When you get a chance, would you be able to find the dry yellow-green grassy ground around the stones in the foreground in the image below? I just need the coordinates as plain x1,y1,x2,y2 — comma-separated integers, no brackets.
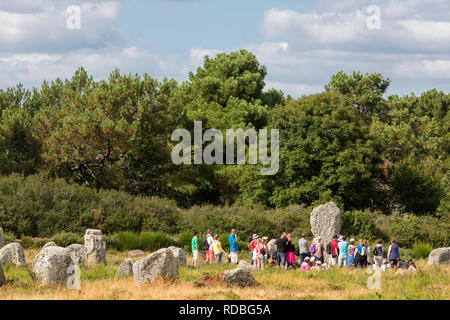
0,249,450,300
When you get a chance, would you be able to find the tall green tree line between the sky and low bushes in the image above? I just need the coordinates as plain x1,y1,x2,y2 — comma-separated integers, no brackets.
0,50,450,217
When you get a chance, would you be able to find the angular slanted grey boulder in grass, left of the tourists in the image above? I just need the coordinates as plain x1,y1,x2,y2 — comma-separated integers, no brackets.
133,249,178,284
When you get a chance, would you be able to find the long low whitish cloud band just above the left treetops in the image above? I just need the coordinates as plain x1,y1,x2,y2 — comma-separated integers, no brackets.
0,47,182,88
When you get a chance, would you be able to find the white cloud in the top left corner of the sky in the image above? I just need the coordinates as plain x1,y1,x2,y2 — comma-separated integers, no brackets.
0,0,125,53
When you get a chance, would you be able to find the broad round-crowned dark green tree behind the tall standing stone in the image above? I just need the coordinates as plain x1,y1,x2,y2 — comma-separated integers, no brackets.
239,92,380,209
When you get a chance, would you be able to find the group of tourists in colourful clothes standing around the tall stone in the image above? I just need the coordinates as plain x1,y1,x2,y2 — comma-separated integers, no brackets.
188,229,416,271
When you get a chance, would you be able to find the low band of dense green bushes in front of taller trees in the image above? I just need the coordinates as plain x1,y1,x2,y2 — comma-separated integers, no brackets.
0,173,450,250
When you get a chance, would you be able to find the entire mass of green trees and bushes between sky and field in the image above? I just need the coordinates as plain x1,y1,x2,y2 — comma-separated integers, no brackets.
0,50,450,234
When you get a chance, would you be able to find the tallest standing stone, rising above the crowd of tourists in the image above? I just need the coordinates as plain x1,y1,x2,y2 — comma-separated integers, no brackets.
310,202,341,263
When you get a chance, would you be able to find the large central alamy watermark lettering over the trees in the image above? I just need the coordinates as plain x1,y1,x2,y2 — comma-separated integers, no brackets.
171,121,280,175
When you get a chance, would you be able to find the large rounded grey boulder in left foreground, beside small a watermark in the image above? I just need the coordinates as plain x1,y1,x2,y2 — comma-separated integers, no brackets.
33,246,73,285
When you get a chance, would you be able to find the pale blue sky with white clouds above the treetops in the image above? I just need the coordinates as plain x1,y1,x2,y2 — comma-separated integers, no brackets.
0,0,450,97
